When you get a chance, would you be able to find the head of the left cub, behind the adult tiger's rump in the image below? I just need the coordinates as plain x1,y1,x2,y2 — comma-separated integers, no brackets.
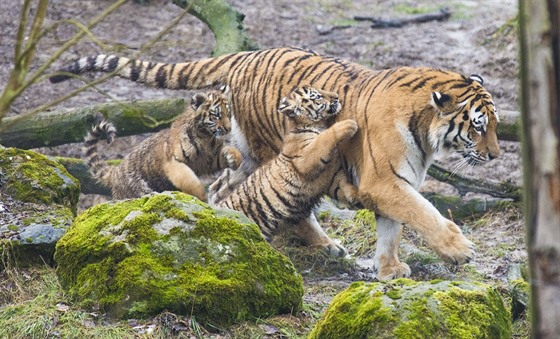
191,86,231,137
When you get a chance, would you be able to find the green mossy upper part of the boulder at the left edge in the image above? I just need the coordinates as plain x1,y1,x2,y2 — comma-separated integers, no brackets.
0,148,80,213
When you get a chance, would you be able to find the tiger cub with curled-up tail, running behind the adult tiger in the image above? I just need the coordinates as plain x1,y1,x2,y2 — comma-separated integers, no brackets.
85,86,242,201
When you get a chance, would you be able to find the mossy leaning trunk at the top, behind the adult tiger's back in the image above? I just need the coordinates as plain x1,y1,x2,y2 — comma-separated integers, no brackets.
173,0,258,56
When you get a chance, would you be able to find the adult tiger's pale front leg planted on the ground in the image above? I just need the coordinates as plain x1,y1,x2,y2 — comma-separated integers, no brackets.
373,216,410,280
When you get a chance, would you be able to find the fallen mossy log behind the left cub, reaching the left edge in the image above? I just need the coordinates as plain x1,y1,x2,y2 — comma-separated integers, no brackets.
0,99,185,149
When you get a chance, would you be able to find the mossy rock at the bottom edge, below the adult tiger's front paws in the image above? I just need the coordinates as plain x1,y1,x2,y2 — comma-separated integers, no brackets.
309,279,511,338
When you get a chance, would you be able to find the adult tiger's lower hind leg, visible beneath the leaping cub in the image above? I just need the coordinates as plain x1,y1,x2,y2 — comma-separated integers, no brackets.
294,213,348,257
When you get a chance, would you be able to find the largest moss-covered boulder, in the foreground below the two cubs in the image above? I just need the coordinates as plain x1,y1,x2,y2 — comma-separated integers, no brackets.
55,192,303,326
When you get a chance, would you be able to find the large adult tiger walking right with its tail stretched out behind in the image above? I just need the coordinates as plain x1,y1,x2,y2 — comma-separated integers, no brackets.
51,48,500,279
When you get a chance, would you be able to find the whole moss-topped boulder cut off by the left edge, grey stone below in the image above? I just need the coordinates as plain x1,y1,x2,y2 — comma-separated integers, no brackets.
0,147,80,267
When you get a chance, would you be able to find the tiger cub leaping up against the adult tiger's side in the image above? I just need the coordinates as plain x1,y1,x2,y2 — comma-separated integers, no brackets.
217,86,358,240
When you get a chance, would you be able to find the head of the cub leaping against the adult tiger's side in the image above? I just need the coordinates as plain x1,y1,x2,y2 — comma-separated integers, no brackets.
278,86,342,127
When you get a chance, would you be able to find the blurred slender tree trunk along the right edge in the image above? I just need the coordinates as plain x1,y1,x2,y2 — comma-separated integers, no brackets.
519,0,560,338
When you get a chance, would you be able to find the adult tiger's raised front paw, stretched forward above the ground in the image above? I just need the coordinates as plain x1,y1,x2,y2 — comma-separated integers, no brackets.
429,221,474,265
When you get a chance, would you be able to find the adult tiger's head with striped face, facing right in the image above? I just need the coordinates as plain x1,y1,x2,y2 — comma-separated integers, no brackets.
430,74,500,165
